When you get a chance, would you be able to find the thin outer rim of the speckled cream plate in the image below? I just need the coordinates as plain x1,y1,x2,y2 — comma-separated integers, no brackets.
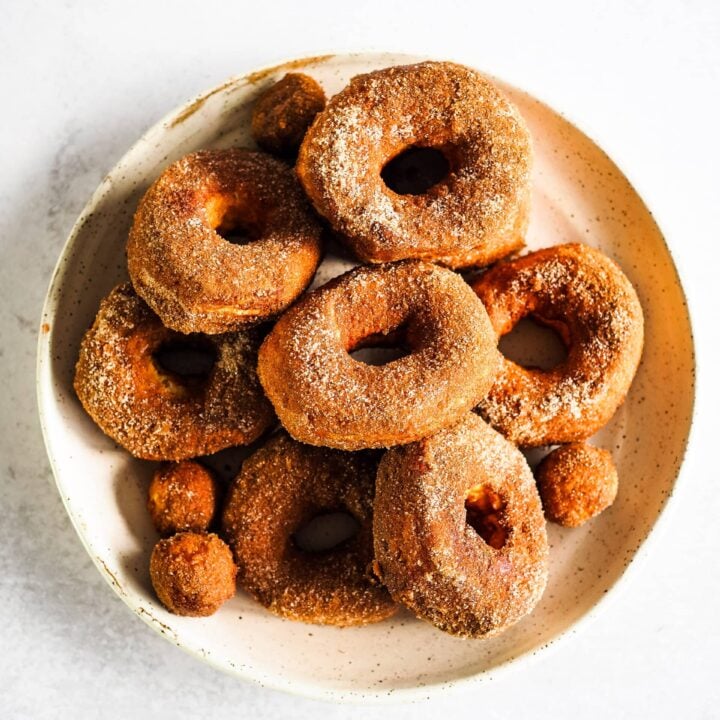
35,49,698,704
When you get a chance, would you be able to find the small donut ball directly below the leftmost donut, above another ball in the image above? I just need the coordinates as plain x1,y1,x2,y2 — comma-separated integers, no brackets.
148,460,219,535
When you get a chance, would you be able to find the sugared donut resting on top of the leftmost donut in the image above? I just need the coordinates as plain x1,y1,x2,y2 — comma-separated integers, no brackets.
127,148,321,334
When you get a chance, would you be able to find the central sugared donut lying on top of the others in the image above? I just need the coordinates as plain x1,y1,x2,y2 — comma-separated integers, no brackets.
258,260,499,450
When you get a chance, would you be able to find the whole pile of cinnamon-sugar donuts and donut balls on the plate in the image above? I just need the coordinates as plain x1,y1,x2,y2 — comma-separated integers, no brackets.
75,62,643,638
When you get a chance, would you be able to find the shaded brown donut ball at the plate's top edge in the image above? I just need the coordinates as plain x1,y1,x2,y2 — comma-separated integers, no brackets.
252,73,325,156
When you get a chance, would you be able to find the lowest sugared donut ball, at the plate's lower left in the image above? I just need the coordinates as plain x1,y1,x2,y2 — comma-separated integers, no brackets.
150,532,237,617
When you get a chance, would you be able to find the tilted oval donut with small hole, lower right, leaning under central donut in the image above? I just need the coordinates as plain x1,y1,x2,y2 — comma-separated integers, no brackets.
373,413,548,638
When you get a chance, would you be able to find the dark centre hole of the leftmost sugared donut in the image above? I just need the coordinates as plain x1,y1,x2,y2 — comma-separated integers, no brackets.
152,333,218,388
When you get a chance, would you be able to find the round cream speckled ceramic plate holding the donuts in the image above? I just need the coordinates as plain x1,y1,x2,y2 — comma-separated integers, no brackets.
38,54,694,700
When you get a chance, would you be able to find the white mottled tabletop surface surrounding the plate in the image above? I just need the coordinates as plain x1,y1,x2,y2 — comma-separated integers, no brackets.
0,0,720,720
